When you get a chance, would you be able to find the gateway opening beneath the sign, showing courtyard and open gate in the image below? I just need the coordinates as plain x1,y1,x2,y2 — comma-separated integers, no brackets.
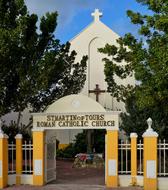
46,130,105,185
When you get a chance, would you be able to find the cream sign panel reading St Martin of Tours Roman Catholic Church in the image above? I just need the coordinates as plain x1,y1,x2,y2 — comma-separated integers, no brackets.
33,112,118,129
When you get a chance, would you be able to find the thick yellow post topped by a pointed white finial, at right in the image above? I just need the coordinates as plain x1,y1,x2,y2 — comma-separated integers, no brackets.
143,118,158,190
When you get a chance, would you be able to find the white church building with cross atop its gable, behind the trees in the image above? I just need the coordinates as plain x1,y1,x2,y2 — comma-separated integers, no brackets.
2,9,135,148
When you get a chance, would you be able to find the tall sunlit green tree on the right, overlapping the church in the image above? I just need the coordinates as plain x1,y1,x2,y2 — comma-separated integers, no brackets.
100,0,168,137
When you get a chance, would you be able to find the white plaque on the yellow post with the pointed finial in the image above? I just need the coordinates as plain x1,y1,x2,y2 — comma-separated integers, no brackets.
146,160,156,179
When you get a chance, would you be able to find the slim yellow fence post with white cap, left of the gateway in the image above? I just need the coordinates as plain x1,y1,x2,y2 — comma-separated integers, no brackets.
15,134,23,185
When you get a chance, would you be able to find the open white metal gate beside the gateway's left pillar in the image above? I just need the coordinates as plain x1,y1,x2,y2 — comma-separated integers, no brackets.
45,132,56,183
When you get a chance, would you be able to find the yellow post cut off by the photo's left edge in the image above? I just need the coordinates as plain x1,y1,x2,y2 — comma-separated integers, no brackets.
0,120,8,189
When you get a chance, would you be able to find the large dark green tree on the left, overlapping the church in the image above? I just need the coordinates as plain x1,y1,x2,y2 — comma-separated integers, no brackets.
0,0,87,127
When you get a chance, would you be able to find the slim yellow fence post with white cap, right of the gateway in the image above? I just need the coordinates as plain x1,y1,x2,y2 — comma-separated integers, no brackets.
130,133,138,185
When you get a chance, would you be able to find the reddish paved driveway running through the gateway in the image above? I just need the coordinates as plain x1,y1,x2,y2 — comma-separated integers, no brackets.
5,161,142,190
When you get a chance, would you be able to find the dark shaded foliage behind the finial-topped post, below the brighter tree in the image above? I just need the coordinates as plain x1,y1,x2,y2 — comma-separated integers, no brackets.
120,95,168,139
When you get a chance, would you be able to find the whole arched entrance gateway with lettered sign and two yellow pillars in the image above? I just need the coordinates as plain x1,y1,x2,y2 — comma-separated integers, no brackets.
32,95,119,187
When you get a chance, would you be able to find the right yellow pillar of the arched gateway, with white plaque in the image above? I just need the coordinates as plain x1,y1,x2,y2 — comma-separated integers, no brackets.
106,129,118,187
